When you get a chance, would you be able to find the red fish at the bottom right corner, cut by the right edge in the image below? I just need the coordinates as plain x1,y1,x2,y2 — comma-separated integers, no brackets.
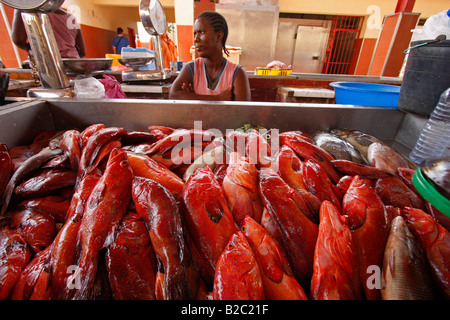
402,207,450,299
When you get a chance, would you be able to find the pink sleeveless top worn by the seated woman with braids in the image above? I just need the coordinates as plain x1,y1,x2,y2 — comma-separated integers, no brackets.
194,57,236,95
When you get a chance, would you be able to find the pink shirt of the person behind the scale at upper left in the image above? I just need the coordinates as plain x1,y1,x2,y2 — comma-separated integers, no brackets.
47,12,80,59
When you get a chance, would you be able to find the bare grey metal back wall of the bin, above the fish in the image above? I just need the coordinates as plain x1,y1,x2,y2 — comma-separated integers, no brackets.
0,99,423,157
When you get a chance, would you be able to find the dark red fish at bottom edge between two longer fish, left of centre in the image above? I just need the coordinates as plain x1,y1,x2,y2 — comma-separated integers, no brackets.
106,212,156,300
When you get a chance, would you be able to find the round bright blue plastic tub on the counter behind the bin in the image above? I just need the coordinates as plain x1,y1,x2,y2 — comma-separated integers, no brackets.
330,82,400,108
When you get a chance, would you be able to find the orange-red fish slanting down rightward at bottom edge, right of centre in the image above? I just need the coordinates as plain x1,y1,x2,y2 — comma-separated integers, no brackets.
241,216,308,300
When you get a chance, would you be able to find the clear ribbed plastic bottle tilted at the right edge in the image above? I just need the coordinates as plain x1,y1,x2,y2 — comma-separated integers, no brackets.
409,88,450,165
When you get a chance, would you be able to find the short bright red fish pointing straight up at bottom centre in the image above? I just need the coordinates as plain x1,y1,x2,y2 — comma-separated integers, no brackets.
213,231,264,300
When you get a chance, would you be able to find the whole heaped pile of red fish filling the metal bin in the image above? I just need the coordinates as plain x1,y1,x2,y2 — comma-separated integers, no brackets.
0,124,450,300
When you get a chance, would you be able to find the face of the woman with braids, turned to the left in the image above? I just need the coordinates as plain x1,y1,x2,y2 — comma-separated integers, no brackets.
194,18,223,58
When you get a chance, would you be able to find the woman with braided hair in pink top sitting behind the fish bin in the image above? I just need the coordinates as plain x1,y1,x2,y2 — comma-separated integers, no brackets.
169,11,251,101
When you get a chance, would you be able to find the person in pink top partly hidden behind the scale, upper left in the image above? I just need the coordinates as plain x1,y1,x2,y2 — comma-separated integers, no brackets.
11,8,86,59
